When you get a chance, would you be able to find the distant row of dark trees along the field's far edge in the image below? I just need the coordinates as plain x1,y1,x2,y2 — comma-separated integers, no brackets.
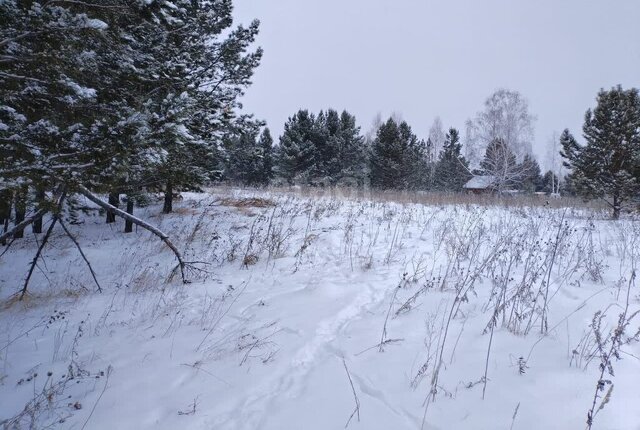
223,109,559,193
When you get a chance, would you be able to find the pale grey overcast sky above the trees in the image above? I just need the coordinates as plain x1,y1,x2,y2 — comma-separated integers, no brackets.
234,0,640,162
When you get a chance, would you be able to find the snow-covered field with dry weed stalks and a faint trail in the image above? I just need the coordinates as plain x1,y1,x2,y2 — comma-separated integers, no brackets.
0,189,640,430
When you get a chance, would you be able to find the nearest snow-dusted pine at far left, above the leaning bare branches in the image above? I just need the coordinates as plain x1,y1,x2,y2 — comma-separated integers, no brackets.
0,0,146,228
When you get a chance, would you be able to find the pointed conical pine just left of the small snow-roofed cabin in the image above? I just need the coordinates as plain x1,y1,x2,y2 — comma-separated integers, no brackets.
434,128,471,191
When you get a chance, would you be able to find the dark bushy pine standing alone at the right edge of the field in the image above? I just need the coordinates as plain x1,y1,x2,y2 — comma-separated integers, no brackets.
561,86,640,219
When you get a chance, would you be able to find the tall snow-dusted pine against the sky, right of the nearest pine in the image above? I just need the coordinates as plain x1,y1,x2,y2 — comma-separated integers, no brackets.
131,0,262,213
